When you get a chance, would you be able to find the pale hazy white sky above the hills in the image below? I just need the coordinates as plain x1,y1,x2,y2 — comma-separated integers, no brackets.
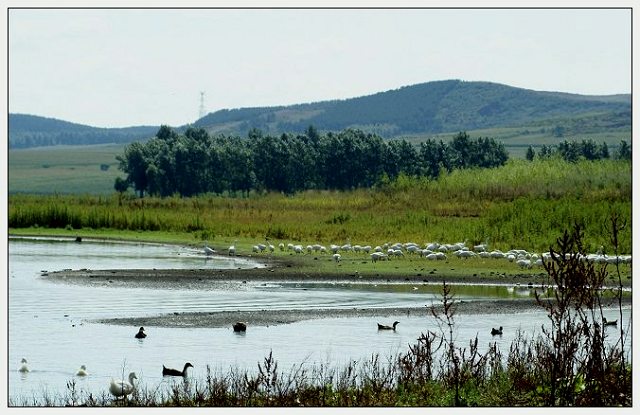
8,4,632,127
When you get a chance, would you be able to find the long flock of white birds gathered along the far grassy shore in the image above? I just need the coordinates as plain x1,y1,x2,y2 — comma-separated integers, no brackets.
224,241,631,269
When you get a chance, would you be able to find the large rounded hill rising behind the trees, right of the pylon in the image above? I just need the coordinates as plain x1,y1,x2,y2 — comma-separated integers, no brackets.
195,80,631,137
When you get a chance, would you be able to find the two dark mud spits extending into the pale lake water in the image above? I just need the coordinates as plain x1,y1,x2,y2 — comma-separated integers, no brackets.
42,259,631,328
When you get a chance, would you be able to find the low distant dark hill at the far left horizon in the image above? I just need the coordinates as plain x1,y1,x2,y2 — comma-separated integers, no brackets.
9,114,159,148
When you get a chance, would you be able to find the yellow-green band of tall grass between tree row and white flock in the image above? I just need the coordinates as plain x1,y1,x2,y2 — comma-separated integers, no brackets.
8,159,631,253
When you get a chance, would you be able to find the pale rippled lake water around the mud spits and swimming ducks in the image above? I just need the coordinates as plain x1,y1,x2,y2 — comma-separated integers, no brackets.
8,238,631,405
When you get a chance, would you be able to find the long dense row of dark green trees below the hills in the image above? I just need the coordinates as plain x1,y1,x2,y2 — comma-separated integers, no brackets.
114,126,508,197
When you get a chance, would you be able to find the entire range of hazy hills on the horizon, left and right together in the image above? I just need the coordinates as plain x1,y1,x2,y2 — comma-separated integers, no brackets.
9,80,631,148
